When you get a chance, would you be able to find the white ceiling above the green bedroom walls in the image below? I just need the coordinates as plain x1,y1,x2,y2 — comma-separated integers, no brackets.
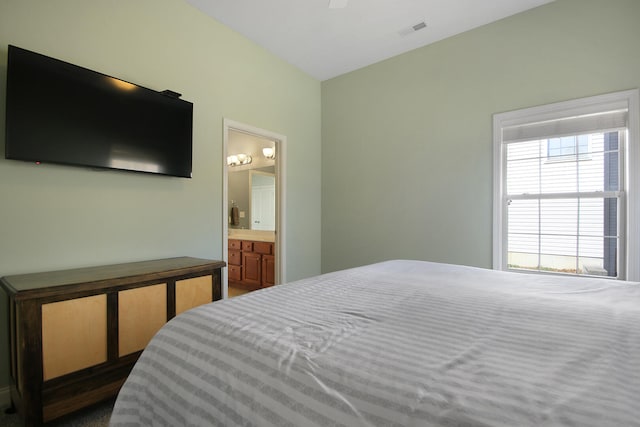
187,0,553,80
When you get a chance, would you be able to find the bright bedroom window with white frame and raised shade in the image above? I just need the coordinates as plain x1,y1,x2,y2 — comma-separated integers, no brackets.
493,90,640,280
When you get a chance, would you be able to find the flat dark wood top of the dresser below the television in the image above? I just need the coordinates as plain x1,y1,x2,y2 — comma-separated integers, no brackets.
1,257,226,294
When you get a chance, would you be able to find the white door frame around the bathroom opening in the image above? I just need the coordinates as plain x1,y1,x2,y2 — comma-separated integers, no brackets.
222,118,287,298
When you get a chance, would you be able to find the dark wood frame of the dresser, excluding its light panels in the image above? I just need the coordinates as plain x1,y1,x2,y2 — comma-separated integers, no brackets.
0,257,225,426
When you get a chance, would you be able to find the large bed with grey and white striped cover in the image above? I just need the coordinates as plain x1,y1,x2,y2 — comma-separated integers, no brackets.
111,260,640,427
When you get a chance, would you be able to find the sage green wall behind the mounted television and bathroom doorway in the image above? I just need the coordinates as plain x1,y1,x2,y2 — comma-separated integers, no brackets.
0,0,321,391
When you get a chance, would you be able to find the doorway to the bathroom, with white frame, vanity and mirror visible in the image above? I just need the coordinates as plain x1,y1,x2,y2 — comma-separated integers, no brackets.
222,119,286,298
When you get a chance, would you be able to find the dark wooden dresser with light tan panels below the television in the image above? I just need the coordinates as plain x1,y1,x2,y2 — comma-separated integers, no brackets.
0,257,225,426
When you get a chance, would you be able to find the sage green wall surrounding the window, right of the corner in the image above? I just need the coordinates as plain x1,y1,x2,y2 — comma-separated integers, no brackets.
322,0,640,272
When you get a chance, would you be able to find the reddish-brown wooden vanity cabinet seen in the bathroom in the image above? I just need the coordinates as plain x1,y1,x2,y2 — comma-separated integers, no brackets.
228,239,276,290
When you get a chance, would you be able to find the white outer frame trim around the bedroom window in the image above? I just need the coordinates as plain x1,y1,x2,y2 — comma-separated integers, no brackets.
493,89,640,281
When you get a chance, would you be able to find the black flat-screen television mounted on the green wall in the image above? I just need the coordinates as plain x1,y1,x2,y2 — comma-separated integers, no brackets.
5,46,193,178
